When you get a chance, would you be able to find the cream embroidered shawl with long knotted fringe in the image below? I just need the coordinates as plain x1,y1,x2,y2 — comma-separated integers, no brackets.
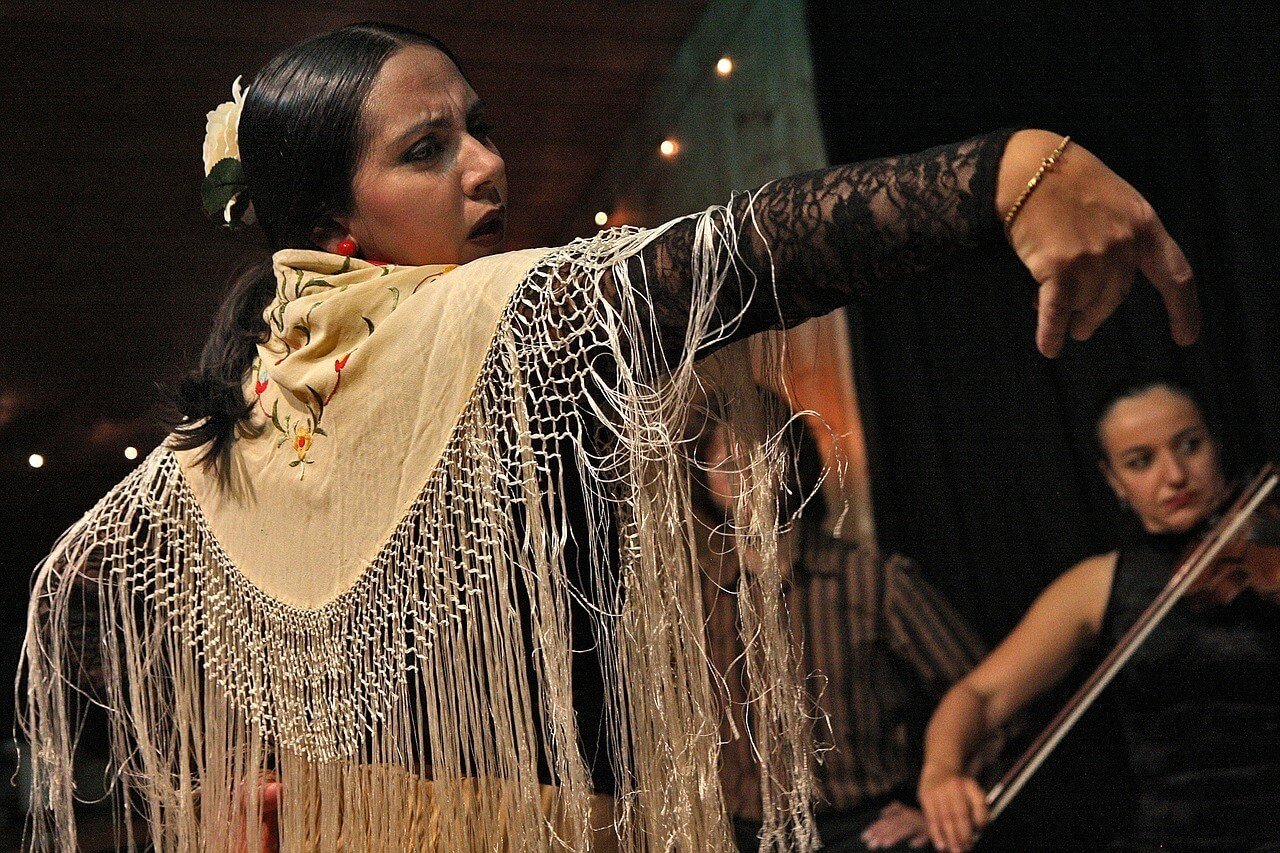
23,209,814,850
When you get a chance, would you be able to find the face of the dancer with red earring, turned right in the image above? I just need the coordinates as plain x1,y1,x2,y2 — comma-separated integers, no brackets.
326,45,507,264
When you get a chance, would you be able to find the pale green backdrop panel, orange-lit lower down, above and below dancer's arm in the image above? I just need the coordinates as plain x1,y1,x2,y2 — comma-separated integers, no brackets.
568,0,876,548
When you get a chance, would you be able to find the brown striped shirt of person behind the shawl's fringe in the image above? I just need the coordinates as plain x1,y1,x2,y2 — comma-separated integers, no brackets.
699,526,986,820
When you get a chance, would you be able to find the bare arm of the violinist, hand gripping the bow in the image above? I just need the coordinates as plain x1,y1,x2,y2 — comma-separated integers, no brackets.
919,552,1116,850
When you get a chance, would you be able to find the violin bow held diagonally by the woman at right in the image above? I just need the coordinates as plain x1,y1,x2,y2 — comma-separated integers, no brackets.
987,462,1280,820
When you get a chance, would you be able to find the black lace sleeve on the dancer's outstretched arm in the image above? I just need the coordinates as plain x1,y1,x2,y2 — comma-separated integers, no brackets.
643,129,1014,356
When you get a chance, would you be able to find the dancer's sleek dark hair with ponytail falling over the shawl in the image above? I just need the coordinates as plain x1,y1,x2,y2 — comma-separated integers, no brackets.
168,22,461,471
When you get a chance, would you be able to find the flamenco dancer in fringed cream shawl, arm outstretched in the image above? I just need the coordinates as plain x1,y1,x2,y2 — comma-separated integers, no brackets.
22,23,1198,850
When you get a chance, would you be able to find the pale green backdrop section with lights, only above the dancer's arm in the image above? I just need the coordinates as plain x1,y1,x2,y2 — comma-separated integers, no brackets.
570,0,827,233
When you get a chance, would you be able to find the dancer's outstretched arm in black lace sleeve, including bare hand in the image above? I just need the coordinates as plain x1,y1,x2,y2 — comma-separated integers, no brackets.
634,131,1199,356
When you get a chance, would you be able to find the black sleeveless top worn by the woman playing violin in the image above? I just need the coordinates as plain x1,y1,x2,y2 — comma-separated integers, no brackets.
1101,527,1280,850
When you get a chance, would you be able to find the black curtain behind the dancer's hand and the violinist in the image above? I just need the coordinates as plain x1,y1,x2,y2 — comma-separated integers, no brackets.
809,0,1280,843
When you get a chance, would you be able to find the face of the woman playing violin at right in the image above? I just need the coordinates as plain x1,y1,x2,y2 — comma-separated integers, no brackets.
1098,386,1226,533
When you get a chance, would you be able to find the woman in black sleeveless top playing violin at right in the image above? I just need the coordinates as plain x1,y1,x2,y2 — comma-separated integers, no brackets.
919,380,1280,850
